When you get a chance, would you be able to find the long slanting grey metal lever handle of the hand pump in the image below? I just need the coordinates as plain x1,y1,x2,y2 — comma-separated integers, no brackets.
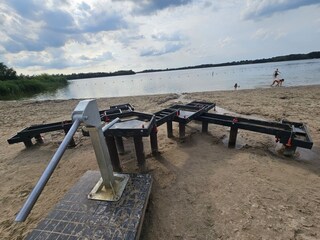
15,119,81,222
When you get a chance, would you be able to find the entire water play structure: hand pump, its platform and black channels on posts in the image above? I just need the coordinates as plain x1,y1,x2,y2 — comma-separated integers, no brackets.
8,100,313,239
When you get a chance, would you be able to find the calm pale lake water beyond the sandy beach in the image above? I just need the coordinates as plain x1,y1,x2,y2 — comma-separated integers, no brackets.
33,59,320,100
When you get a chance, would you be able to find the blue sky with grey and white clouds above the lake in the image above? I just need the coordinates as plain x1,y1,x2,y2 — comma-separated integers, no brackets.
0,0,320,74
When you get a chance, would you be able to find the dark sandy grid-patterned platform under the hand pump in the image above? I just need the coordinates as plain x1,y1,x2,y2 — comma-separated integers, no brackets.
26,171,152,240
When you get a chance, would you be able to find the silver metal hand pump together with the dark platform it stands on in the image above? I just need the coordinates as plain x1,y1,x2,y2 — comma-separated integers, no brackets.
16,100,152,239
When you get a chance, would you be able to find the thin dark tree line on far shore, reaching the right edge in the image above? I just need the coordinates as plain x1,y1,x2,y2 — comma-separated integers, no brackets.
138,52,320,73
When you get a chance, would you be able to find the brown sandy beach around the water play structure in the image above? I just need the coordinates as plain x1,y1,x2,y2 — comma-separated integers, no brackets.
0,86,320,239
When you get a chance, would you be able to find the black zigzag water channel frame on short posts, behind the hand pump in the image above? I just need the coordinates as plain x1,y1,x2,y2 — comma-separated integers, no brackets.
7,101,313,152
